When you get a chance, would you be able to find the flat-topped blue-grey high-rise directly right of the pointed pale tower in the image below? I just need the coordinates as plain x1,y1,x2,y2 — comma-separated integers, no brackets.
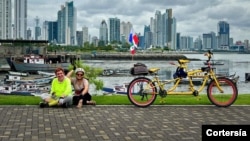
109,18,120,43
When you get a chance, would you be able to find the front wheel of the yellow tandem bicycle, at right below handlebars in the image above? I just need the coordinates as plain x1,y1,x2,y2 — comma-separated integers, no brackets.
207,77,238,107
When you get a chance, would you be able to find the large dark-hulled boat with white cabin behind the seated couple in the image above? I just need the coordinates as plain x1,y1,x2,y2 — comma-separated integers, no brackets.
6,54,77,73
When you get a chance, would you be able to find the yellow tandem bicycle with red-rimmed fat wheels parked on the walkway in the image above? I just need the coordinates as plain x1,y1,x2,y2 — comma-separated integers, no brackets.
127,51,238,107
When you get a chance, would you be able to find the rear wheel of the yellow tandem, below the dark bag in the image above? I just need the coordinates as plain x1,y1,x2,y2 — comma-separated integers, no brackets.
127,77,157,107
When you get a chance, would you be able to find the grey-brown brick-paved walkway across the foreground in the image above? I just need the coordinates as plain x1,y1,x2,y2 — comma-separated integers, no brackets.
0,105,250,141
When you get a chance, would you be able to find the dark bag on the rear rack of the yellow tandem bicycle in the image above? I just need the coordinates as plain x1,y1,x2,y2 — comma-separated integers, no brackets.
130,63,148,75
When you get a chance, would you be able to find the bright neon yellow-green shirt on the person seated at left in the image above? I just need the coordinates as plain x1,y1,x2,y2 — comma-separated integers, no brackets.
50,77,72,97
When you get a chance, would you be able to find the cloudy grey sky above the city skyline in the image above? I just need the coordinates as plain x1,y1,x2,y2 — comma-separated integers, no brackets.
28,0,250,42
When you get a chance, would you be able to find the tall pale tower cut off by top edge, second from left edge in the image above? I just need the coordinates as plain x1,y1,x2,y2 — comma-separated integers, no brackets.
13,0,27,39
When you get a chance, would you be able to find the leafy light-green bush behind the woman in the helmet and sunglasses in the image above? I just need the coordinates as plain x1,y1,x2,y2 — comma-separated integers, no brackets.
69,60,104,90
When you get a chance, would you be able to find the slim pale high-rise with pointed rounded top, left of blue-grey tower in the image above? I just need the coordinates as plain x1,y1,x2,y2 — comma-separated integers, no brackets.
99,20,108,45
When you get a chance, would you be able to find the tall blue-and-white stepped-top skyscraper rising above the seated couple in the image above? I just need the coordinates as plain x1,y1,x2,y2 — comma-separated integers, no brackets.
57,1,77,45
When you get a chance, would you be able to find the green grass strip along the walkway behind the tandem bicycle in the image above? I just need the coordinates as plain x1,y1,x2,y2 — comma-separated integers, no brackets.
0,94,250,105
